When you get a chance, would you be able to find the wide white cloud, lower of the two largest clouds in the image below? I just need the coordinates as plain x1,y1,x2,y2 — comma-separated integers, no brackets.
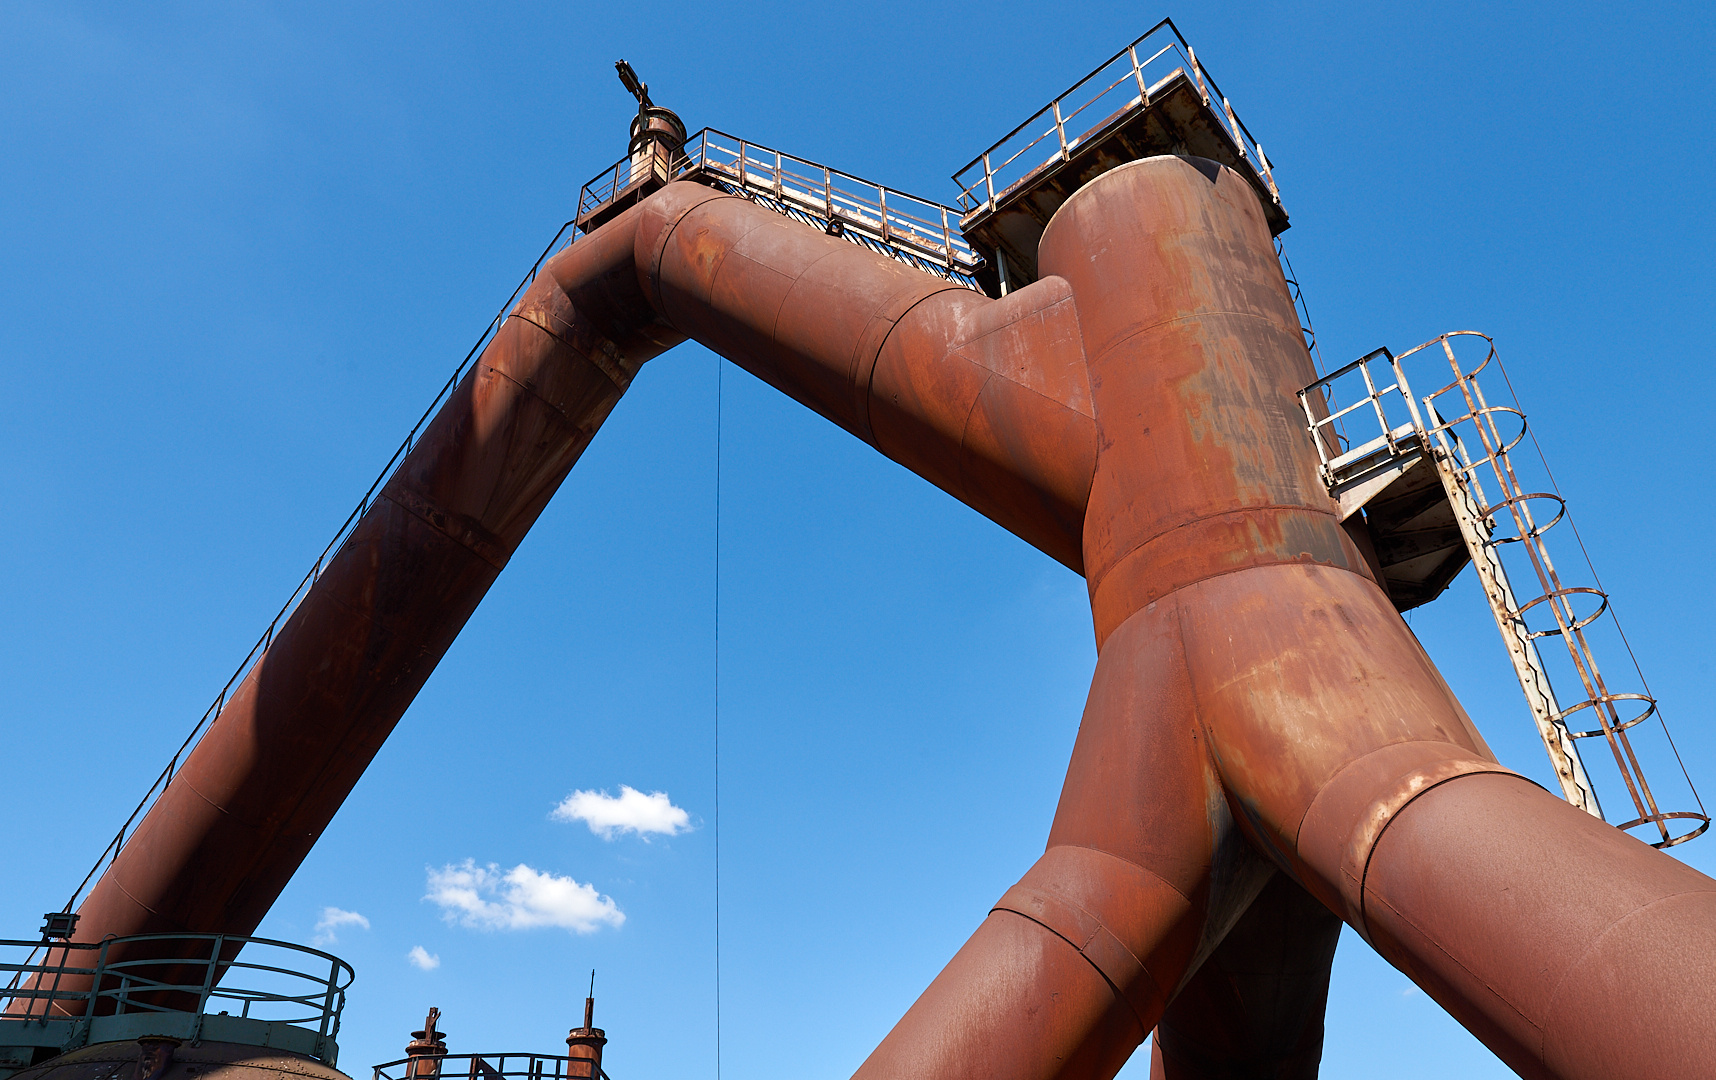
424,859,626,934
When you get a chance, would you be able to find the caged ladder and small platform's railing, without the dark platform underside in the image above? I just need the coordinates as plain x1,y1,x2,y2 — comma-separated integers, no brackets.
1299,330,1711,848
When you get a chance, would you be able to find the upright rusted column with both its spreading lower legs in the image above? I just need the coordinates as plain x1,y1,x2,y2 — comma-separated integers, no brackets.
823,158,1716,1080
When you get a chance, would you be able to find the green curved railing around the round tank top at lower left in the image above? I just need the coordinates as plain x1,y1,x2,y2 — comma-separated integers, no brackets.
0,934,352,1039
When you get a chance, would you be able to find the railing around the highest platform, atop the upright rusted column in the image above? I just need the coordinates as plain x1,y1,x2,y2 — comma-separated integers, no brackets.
954,19,1280,213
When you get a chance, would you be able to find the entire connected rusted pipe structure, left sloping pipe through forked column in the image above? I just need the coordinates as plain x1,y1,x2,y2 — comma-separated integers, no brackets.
50,88,1716,1080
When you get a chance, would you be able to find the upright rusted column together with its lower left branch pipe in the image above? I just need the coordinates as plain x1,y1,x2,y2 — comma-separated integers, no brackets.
860,158,1368,1080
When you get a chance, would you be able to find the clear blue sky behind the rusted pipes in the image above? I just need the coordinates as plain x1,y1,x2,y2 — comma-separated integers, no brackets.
0,2,1716,1080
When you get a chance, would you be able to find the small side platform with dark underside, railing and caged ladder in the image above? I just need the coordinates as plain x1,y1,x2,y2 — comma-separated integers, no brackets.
1299,330,1709,848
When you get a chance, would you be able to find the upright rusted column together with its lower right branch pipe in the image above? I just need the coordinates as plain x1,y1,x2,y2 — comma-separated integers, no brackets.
1042,160,1716,1078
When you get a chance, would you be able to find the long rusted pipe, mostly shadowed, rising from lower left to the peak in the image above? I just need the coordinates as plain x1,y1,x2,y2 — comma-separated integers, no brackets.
58,204,681,975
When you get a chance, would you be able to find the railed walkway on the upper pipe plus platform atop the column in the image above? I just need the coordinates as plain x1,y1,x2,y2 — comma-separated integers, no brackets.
575,19,1287,297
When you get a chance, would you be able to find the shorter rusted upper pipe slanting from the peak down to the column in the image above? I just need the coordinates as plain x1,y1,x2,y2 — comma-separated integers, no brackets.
637,182,1097,570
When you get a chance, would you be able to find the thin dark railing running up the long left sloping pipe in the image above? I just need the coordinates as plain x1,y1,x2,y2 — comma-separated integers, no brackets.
50,221,580,912
